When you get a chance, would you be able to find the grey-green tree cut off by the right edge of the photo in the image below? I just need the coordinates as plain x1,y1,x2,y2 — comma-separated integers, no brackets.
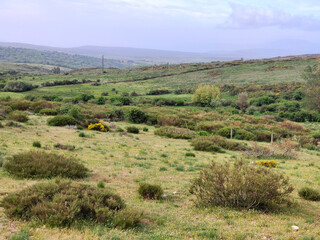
302,63,320,111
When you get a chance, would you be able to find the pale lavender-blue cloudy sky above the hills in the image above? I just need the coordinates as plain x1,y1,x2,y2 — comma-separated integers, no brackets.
0,0,320,52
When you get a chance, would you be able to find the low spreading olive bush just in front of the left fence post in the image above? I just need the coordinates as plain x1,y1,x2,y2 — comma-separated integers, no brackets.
191,136,248,152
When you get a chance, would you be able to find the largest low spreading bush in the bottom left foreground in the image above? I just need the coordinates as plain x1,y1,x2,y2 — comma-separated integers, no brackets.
1,180,131,227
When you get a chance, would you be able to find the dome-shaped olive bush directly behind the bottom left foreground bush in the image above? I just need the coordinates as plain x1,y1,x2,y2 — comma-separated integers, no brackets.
3,151,88,178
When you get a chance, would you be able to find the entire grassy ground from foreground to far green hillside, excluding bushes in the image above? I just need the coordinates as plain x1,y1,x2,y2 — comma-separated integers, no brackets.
0,55,320,240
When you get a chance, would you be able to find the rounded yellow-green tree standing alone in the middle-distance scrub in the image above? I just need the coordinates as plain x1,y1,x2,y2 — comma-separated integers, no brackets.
192,85,221,106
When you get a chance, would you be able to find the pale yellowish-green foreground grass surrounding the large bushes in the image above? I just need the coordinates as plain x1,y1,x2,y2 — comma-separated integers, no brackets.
0,116,320,240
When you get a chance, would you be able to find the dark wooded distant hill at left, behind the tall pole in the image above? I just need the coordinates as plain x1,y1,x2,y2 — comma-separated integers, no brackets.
0,47,134,69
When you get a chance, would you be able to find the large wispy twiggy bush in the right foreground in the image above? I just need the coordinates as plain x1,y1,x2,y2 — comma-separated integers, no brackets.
190,160,293,210
